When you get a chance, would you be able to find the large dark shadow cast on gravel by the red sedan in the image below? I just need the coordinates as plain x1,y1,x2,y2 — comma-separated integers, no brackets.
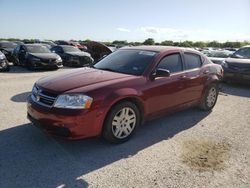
0,109,209,187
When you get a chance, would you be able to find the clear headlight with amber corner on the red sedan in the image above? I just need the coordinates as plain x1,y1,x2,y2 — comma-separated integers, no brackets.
54,94,93,109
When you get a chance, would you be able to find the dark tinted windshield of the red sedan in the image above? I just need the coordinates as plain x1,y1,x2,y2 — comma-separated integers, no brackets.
94,50,156,75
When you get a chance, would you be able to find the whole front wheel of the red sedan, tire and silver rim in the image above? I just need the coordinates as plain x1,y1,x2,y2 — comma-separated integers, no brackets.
102,101,141,144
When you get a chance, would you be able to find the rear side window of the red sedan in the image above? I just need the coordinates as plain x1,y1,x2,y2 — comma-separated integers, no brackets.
184,53,202,69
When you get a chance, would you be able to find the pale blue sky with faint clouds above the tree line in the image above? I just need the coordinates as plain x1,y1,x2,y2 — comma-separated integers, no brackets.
0,0,250,42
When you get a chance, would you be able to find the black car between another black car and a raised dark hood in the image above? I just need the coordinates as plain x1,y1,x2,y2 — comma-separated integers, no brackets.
51,45,93,67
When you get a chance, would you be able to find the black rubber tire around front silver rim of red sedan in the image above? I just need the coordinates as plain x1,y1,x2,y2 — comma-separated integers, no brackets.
103,102,141,143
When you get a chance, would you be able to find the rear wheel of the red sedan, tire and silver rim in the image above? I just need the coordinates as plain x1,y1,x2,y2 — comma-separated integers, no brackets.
199,84,219,111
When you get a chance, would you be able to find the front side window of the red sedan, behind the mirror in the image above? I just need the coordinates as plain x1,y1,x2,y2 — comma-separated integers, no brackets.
157,54,182,73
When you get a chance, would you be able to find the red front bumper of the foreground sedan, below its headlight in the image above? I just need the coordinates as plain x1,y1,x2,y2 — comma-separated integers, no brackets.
27,96,104,140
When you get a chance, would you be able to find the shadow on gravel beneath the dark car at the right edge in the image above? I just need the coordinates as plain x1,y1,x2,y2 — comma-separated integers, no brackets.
221,83,250,98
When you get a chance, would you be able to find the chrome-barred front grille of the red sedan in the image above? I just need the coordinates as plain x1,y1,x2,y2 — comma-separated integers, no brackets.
32,86,57,107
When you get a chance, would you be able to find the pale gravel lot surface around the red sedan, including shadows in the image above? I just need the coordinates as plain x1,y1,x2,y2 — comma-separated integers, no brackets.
0,67,250,188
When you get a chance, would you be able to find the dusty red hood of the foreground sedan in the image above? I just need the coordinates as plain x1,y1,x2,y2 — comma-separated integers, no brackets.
36,67,133,94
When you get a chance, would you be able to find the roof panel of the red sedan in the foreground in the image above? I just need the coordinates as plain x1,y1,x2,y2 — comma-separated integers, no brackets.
121,46,195,53
